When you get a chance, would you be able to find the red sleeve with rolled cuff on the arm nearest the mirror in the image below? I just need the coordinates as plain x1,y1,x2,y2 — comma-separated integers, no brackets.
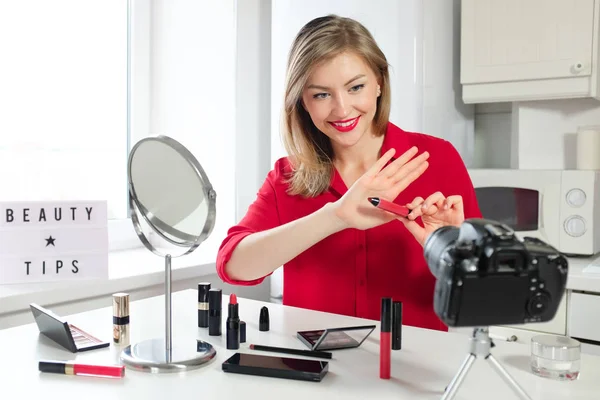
216,168,280,286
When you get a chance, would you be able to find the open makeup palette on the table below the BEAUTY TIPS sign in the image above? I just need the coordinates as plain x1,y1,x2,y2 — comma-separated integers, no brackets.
29,303,110,353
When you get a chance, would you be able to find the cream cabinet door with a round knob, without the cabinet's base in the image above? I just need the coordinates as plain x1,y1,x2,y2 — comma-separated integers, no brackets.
461,0,594,84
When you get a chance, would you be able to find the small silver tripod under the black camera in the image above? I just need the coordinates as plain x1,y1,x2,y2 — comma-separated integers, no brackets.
442,328,531,400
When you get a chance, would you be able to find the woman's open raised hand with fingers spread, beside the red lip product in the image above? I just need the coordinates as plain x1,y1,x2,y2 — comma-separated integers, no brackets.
333,147,429,230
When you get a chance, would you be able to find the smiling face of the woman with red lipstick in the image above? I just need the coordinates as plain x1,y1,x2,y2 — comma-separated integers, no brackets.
302,52,379,149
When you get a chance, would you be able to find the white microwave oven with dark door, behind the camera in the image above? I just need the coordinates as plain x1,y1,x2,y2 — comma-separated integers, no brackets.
468,169,600,256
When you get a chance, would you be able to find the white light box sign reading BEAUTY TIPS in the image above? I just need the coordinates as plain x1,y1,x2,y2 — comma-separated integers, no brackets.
0,201,108,284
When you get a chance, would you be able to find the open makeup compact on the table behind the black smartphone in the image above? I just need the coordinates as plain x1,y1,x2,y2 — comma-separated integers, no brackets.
296,325,375,350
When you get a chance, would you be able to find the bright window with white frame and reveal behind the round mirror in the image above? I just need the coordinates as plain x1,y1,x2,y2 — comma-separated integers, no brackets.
0,0,235,255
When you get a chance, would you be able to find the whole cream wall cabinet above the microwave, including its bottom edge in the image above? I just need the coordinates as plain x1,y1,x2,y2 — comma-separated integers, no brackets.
460,0,600,103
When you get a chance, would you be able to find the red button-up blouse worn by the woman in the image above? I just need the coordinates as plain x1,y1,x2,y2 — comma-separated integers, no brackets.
216,123,481,330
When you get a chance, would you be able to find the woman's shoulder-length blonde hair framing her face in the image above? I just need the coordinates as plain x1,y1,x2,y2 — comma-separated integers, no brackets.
282,15,391,197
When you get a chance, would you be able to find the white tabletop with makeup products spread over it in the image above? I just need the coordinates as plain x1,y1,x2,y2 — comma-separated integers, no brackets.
0,290,600,400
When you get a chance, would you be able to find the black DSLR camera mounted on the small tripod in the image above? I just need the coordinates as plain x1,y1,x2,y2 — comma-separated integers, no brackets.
424,218,568,327
